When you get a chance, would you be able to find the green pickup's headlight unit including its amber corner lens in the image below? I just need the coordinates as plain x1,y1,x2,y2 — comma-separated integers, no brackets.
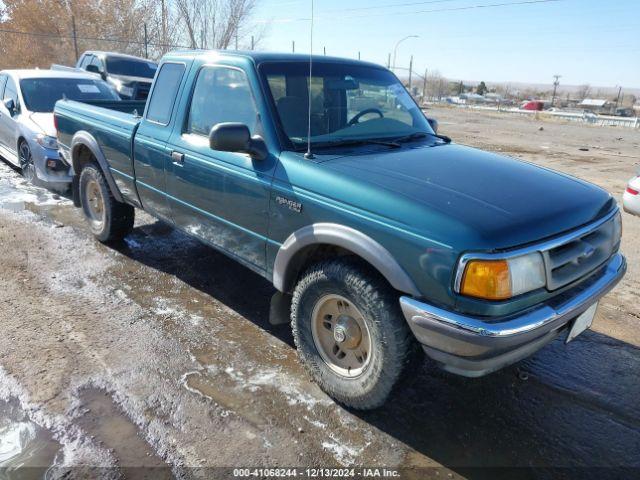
459,252,547,300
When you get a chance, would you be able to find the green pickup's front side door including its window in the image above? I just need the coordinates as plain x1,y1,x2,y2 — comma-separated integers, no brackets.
167,65,276,271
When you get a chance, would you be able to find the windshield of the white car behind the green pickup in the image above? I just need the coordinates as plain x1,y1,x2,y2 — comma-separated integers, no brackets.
20,78,120,113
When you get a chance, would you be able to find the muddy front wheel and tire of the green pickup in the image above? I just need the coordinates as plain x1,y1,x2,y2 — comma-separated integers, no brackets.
291,257,414,410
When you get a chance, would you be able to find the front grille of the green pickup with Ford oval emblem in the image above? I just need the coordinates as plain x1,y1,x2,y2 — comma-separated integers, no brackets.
542,215,621,290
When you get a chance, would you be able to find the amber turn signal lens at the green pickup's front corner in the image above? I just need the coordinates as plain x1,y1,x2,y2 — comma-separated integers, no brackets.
460,260,512,300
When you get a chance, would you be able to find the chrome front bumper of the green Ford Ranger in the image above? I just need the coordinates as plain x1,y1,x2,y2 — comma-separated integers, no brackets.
400,253,627,377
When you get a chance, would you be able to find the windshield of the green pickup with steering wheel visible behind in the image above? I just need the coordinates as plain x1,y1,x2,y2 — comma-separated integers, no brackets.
260,62,434,148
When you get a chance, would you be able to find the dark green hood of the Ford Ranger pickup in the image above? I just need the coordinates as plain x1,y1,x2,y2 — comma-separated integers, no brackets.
323,144,615,249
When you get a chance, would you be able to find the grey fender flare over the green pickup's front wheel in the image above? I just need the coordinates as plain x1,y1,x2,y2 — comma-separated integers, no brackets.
273,223,421,297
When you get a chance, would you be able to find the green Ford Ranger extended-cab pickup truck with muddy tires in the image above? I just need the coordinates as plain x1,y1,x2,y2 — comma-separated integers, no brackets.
55,51,626,409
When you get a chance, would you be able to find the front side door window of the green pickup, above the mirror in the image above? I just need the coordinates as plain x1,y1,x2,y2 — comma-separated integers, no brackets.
187,67,258,135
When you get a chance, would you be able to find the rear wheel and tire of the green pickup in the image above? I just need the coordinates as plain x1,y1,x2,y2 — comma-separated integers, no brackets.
80,164,135,243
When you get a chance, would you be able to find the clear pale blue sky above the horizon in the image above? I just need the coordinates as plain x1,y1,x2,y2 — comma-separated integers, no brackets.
256,0,640,88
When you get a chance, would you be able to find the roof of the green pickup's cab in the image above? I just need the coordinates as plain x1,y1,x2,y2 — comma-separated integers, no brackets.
166,50,381,68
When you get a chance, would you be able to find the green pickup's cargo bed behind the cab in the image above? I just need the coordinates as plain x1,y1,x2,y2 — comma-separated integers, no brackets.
54,100,145,203
